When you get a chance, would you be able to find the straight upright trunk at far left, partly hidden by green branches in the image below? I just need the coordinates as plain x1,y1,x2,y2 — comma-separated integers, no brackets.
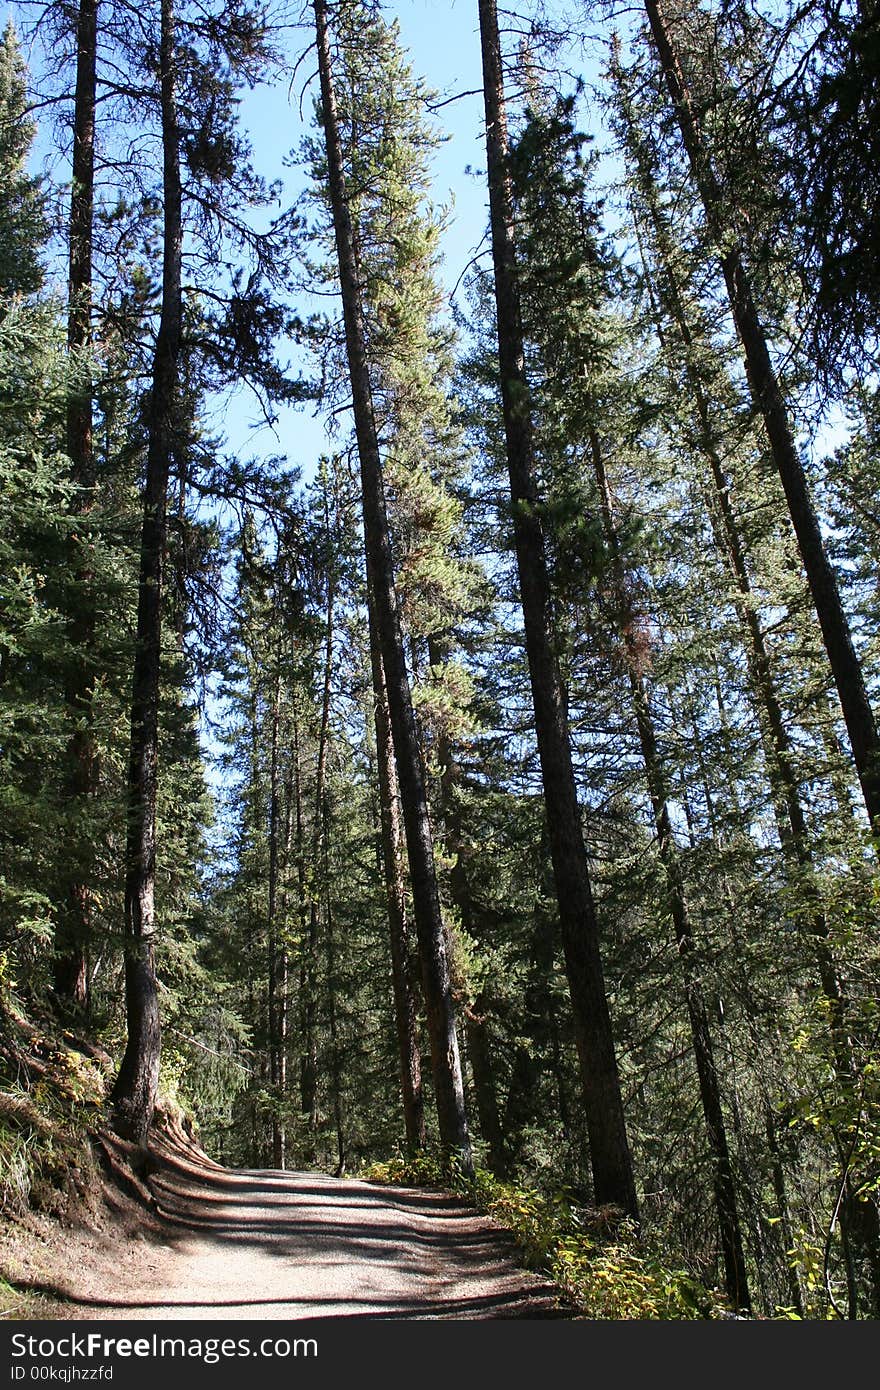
54,0,97,1008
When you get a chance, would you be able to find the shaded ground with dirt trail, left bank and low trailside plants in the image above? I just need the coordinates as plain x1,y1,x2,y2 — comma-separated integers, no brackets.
0,998,731,1321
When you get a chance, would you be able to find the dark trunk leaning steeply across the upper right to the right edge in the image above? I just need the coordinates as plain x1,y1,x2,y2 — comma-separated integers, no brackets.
645,0,880,830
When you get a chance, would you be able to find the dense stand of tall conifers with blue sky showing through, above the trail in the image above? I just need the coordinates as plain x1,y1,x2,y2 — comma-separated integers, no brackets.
0,0,880,1318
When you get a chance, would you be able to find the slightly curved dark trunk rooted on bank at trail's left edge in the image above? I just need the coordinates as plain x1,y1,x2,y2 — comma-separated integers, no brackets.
113,0,182,1144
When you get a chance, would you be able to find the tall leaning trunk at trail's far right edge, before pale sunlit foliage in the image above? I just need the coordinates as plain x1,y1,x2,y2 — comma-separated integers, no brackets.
314,0,473,1173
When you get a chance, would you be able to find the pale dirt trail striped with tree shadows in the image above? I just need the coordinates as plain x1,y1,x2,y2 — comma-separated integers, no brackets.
30,1144,564,1321
